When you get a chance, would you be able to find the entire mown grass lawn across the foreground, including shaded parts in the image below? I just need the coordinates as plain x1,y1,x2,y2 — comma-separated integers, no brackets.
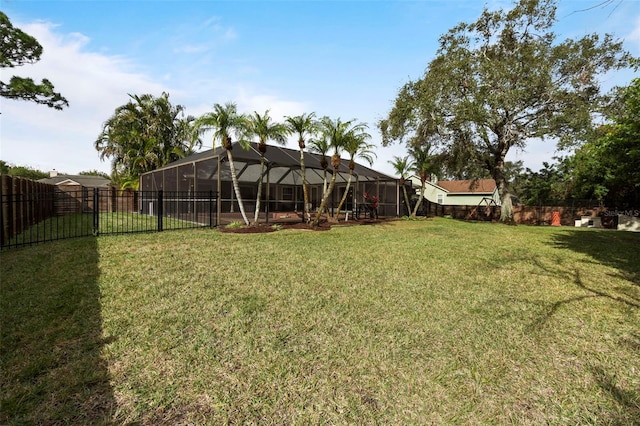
0,219,640,425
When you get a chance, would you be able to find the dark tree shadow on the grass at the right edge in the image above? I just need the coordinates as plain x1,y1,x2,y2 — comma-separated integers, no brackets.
553,230,640,286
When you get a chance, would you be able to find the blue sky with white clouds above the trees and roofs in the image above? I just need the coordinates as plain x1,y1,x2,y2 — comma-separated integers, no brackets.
0,0,640,176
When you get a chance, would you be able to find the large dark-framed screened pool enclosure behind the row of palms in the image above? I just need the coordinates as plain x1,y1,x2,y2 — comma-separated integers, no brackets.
140,143,404,223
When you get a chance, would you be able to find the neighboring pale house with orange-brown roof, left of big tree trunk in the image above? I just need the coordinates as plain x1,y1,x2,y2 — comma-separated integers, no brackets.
414,179,500,206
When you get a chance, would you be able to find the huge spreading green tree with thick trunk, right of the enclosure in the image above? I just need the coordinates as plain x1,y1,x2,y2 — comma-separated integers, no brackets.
379,0,631,221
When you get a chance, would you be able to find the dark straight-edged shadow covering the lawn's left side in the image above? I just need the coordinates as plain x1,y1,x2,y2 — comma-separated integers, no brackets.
0,237,116,424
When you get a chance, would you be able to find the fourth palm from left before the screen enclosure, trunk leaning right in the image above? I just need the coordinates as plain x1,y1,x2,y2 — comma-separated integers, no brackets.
313,117,366,226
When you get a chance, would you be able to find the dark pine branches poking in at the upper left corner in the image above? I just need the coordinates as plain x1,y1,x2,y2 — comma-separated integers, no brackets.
0,12,69,110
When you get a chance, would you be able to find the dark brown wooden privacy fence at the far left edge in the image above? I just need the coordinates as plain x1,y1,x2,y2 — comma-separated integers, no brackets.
0,175,56,246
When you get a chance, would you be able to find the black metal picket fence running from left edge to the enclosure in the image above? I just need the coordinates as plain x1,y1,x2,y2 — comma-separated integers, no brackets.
0,187,219,249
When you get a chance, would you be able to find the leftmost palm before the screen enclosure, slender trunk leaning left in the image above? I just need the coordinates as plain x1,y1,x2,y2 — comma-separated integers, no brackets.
195,102,249,225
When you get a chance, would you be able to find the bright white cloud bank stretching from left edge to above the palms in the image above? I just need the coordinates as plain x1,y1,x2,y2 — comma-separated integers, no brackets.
0,18,316,173
